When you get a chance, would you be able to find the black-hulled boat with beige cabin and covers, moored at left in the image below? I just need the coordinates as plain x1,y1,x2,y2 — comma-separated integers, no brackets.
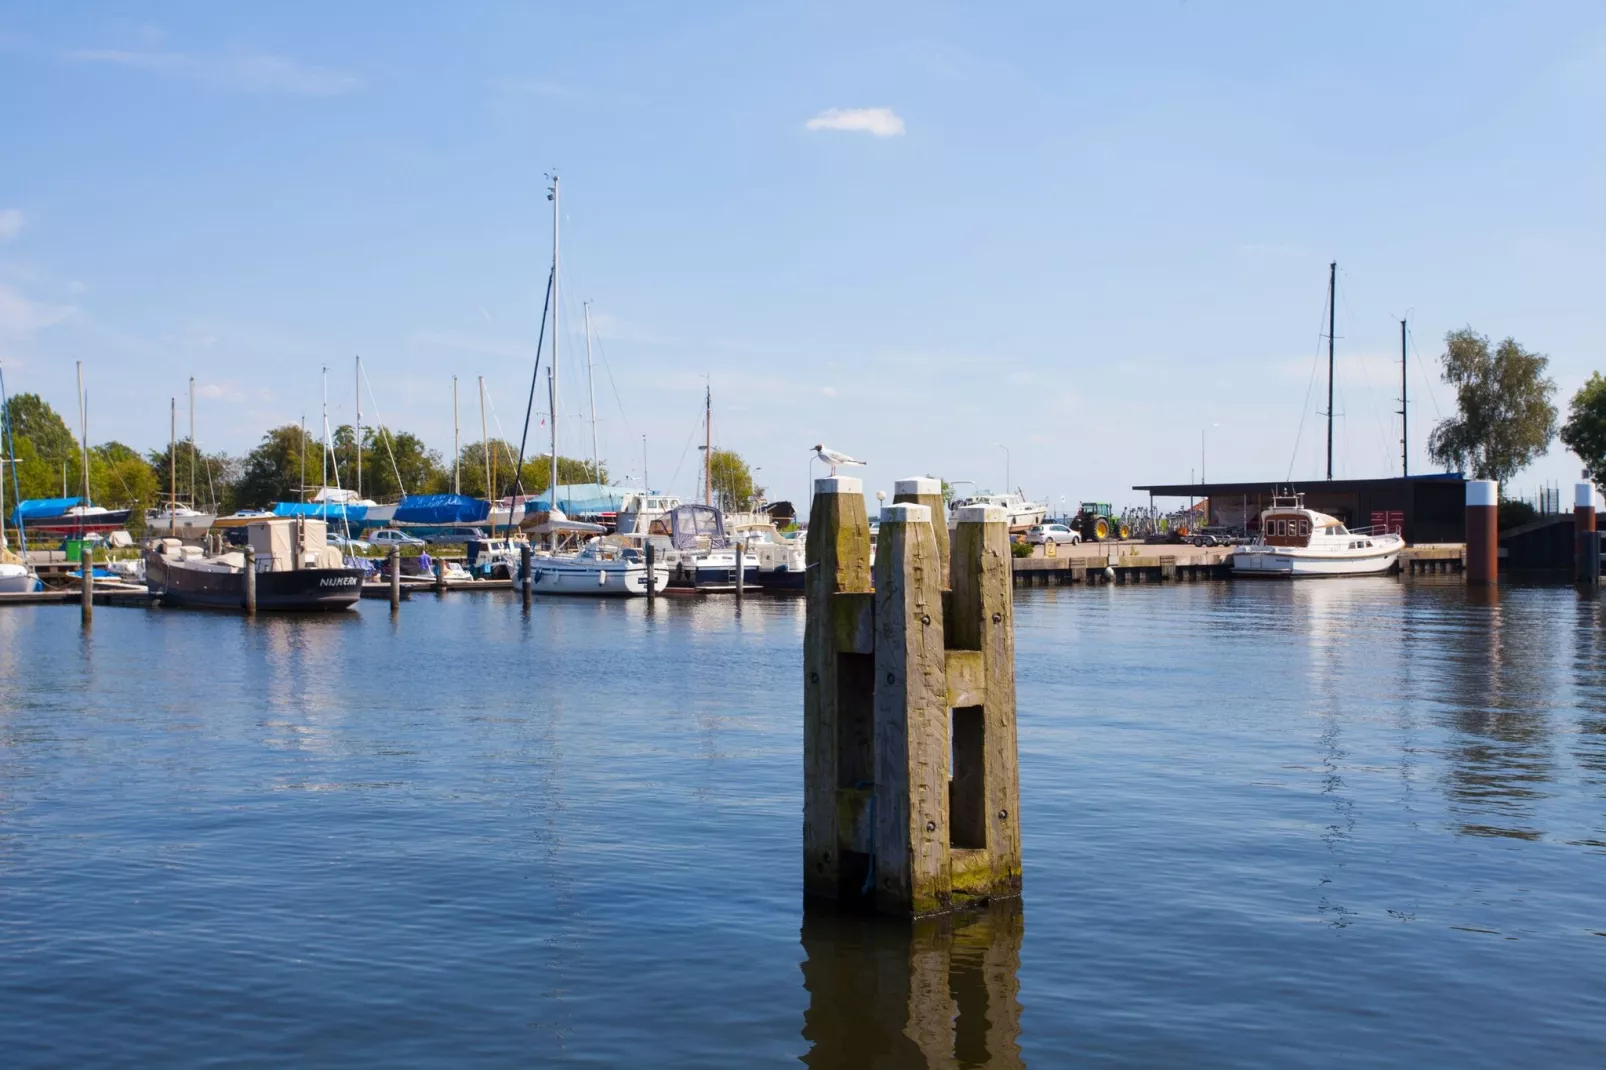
145,517,363,611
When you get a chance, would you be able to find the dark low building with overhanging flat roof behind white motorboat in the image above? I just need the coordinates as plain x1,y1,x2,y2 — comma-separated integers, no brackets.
1132,472,1466,543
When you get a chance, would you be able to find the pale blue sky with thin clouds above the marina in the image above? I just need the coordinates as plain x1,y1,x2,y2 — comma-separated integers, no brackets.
0,0,1606,503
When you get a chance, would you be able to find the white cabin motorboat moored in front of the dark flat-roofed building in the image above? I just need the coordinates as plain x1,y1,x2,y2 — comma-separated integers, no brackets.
1232,495,1405,577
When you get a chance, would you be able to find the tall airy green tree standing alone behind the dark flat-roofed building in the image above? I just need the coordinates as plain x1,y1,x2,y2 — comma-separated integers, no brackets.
1428,328,1556,484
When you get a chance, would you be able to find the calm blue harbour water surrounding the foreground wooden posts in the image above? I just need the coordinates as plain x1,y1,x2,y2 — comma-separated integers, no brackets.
0,580,1606,1068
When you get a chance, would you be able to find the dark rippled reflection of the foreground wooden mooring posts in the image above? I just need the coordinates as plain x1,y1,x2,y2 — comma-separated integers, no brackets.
803,900,1026,1070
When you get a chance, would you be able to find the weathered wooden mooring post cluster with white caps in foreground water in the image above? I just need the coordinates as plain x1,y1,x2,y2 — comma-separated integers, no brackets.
803,477,1020,917
